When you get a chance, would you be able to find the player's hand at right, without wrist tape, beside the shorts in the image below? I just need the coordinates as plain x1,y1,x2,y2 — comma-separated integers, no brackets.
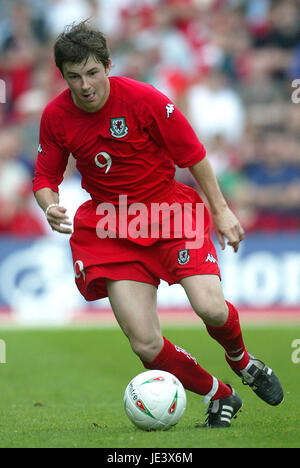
214,207,245,252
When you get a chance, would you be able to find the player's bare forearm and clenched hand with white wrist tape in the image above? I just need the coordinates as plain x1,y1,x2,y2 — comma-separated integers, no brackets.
35,187,72,234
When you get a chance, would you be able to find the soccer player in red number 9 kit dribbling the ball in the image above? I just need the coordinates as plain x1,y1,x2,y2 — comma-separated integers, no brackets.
33,22,283,428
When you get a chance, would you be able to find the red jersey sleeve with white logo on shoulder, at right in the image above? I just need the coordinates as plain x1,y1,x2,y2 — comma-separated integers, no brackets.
143,87,206,167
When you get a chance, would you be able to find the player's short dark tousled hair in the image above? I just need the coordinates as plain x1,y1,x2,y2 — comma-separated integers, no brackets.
54,20,110,75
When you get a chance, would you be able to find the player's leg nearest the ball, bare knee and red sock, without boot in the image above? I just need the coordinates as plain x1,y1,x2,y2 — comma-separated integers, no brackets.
107,280,238,412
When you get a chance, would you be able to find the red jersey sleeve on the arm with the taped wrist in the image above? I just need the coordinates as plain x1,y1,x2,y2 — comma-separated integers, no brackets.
33,108,69,193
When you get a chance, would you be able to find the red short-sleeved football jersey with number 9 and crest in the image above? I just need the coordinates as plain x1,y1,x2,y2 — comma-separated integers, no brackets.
33,77,206,205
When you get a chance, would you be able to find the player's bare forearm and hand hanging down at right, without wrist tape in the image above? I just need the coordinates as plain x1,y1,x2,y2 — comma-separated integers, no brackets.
190,157,245,252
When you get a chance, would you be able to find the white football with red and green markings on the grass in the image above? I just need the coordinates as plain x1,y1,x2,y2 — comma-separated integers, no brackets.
124,370,186,431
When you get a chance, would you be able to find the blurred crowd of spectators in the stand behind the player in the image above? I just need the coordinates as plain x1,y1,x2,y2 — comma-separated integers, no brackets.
0,0,300,237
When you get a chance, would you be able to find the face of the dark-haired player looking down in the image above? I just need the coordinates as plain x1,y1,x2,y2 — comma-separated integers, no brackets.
63,57,111,112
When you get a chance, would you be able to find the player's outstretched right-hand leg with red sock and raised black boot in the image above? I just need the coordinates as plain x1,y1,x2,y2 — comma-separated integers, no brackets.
181,275,283,406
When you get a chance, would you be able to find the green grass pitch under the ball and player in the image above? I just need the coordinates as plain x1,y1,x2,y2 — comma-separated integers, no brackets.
0,325,300,449
